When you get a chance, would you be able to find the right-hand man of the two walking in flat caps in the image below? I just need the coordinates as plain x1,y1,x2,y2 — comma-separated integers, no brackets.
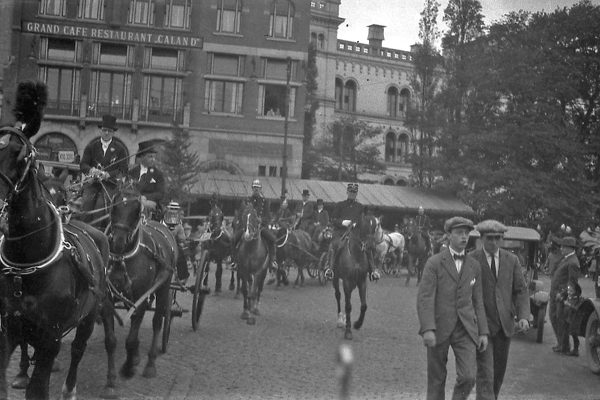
470,220,530,400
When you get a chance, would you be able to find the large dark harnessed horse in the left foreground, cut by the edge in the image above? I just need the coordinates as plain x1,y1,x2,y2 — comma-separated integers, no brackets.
0,128,115,399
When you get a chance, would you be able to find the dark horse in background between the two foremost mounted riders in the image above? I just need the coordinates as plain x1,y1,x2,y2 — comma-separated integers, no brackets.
276,227,318,286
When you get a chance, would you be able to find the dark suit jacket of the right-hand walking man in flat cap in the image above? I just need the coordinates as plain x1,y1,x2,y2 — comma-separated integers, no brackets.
470,249,530,337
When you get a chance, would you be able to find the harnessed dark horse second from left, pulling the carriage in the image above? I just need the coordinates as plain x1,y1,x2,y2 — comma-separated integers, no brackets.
108,186,177,378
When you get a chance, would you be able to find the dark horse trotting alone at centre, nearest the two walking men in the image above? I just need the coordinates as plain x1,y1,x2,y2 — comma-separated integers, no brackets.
333,215,377,340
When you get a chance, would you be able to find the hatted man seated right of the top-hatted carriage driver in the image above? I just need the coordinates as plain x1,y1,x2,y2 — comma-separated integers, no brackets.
129,142,166,220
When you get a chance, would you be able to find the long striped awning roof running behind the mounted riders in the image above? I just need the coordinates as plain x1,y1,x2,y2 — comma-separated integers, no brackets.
193,173,473,215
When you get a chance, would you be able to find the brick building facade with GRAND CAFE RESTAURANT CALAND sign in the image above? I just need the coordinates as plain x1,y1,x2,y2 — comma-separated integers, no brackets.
0,0,310,177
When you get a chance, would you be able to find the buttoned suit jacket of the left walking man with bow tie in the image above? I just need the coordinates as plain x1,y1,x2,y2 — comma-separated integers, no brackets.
417,249,489,344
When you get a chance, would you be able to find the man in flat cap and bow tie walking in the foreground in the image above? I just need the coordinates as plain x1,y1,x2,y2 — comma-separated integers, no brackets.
417,217,489,400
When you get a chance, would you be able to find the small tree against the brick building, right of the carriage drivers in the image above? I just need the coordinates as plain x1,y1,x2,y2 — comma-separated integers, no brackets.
162,126,202,211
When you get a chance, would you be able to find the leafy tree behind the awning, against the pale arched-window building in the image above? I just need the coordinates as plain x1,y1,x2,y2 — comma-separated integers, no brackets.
312,117,385,181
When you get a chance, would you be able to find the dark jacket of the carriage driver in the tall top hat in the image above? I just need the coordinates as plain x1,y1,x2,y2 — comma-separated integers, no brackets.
79,139,127,178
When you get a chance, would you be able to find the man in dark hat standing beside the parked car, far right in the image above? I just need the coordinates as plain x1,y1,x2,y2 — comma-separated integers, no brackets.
548,236,579,354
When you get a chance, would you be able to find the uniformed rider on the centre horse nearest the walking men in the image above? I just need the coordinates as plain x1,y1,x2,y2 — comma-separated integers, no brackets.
325,183,380,280
